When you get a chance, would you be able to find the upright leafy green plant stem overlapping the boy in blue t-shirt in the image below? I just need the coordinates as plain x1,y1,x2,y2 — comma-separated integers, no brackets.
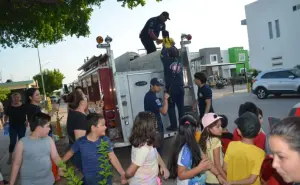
98,140,112,185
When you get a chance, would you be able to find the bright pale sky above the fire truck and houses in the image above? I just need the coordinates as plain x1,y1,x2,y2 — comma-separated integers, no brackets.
0,0,255,83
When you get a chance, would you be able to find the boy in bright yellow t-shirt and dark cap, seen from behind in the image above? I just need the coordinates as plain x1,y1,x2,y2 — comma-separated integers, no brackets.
223,112,265,185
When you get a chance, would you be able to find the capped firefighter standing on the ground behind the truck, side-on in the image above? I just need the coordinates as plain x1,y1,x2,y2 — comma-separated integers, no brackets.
144,78,169,155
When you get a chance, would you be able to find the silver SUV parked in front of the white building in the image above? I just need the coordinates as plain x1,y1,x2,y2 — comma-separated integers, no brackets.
252,68,300,99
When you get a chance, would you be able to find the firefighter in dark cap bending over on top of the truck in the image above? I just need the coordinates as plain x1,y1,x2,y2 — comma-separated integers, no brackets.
140,12,170,54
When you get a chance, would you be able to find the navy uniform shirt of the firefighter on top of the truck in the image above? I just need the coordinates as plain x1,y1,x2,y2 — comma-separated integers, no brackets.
140,17,166,40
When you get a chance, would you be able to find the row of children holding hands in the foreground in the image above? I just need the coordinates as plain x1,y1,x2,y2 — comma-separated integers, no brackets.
5,102,288,185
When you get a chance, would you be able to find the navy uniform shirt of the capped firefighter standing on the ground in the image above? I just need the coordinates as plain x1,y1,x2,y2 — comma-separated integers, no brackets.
144,90,162,124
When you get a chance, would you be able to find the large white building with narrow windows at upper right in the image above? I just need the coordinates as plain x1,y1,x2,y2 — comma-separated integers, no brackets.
242,0,300,70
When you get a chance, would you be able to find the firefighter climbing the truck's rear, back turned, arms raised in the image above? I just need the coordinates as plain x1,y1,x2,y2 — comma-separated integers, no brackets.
160,41,184,131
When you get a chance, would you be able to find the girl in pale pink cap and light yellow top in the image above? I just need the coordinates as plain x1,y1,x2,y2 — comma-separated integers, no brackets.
200,113,226,185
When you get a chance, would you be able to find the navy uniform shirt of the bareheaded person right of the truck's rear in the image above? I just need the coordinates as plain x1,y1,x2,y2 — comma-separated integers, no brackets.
197,85,214,117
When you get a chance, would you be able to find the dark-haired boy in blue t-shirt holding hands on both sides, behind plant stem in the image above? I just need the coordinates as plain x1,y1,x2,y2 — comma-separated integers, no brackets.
63,113,126,185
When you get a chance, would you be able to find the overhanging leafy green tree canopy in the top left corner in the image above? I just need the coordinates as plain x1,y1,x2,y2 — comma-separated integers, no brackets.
0,0,161,48
